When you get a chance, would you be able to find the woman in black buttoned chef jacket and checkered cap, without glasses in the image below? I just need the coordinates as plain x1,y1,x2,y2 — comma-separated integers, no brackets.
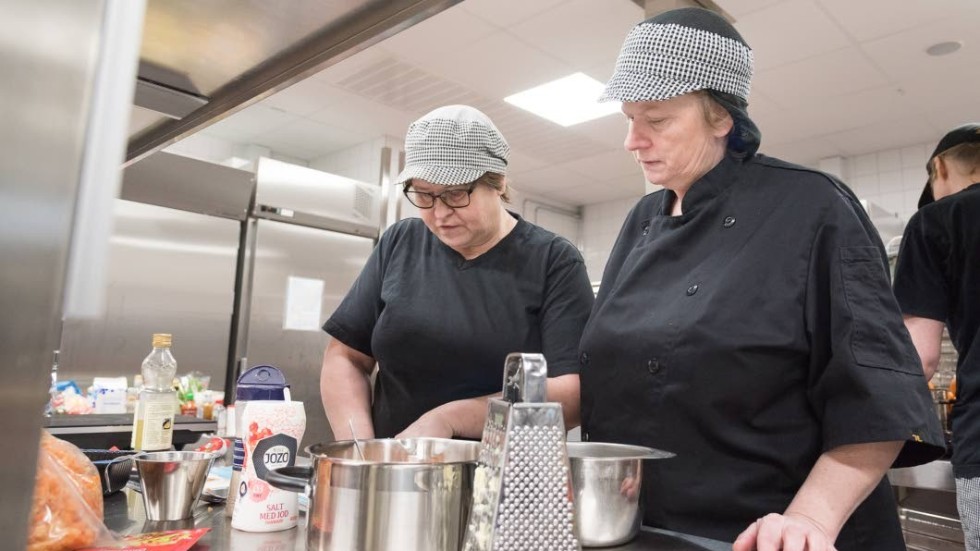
580,8,943,551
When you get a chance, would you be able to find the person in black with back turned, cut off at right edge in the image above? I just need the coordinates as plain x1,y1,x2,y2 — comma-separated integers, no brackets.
895,124,980,551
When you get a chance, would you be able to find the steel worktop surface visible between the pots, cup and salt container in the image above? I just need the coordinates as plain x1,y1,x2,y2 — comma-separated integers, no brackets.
105,488,731,551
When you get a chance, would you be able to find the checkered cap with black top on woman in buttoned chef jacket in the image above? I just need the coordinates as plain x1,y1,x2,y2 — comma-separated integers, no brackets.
599,8,752,101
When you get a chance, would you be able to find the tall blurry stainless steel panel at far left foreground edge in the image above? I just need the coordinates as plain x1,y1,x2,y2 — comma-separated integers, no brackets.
0,0,115,549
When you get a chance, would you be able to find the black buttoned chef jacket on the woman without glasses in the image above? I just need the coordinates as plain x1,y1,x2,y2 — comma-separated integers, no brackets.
580,156,943,551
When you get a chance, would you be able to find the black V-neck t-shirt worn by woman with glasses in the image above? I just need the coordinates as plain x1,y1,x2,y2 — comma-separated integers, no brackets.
323,213,593,438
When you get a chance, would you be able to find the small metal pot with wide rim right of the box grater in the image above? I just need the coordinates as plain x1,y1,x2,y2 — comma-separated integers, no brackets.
567,442,674,547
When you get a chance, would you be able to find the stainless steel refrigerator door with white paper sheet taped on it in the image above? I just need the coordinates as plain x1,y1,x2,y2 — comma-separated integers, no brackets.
242,220,374,447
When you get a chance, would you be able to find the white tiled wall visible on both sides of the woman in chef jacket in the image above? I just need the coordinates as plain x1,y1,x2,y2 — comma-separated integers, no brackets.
581,143,935,282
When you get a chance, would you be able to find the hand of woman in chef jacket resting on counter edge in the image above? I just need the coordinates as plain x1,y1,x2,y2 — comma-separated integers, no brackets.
732,513,837,551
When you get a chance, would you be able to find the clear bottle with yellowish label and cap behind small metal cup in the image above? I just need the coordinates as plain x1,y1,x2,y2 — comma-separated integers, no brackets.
131,333,177,451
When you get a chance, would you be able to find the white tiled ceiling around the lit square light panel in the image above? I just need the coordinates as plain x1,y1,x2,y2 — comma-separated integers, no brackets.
186,0,980,205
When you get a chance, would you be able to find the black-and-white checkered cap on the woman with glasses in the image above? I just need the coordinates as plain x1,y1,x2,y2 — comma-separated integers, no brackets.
395,105,510,186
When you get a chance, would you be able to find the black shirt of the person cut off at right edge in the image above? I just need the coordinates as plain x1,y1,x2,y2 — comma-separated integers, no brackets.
895,183,980,478
